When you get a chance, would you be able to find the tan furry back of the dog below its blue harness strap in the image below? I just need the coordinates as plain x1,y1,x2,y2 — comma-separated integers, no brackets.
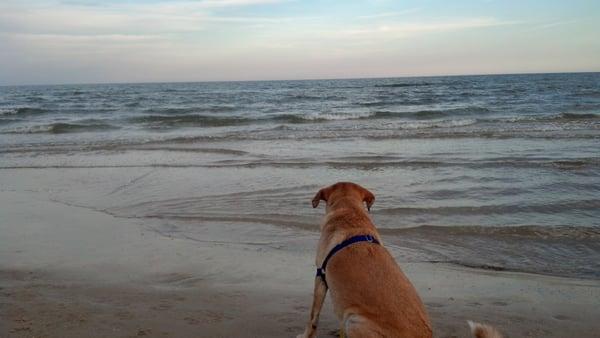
327,239,432,337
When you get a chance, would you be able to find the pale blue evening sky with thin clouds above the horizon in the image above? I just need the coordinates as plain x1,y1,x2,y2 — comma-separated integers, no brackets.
0,0,600,85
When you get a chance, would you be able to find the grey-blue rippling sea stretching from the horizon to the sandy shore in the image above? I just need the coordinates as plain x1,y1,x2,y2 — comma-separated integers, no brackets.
0,73,600,279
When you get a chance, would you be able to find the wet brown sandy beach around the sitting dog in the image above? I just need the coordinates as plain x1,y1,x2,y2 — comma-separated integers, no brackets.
0,186,600,337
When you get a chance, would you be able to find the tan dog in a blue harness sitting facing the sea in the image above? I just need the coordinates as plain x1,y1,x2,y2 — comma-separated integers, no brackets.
297,182,501,338
